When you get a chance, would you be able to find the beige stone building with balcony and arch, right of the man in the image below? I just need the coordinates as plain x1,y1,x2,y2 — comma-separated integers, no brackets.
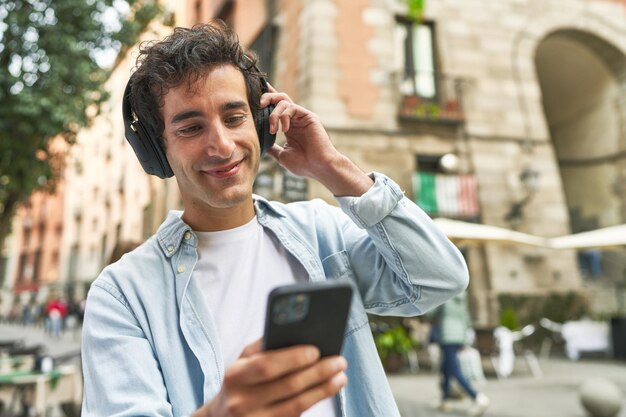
252,0,626,324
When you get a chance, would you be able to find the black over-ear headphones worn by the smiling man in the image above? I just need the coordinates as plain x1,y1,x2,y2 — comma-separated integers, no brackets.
122,72,276,178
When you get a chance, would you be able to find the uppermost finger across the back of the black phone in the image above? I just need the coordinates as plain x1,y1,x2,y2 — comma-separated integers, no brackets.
224,346,320,386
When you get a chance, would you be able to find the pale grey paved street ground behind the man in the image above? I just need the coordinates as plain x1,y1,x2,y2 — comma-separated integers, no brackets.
0,323,626,417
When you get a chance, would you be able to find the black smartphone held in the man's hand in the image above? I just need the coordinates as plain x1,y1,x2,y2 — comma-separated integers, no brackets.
263,281,352,357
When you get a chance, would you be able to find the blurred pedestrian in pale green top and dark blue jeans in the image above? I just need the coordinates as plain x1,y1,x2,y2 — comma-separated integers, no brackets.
428,292,489,416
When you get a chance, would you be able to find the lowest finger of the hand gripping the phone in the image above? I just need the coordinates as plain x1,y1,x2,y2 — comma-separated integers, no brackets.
259,373,348,416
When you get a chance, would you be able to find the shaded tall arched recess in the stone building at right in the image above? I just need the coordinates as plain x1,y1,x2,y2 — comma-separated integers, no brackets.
535,29,626,232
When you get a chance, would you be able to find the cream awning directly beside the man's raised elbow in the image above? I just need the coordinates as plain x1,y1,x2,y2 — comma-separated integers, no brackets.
434,217,548,247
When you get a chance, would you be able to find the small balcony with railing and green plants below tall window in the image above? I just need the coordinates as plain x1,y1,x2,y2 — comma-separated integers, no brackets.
399,72,465,126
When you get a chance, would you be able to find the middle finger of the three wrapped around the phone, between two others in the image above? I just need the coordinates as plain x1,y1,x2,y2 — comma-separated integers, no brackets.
249,356,348,404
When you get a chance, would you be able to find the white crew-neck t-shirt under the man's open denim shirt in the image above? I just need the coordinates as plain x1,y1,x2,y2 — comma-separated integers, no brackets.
192,217,337,417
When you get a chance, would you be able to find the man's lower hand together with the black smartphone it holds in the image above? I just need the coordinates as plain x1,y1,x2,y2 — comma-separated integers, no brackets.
193,281,352,417
